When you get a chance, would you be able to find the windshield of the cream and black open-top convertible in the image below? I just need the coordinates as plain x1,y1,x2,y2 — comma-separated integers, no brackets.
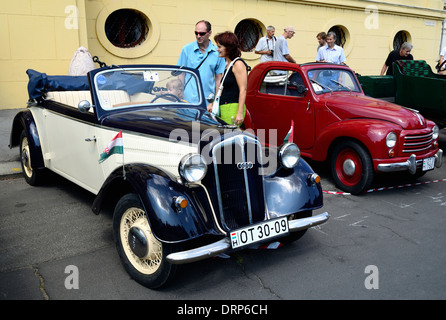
94,67,202,110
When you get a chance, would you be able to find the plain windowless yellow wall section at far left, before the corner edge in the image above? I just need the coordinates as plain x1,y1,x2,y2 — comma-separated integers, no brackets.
0,0,87,109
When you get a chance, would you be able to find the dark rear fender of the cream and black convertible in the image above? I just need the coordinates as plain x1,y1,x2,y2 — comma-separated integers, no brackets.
9,109,45,169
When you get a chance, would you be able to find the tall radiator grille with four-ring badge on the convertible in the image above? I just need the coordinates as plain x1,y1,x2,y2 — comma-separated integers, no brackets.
212,135,265,230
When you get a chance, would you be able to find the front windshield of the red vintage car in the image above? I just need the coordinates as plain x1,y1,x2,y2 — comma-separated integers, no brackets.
308,68,361,94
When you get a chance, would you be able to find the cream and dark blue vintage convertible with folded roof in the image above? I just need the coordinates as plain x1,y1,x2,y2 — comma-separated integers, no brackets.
10,65,329,288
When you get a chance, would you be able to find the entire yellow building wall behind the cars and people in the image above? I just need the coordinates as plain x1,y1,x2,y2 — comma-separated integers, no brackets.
0,0,446,109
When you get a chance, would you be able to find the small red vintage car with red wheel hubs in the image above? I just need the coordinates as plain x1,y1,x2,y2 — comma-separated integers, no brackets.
246,62,443,194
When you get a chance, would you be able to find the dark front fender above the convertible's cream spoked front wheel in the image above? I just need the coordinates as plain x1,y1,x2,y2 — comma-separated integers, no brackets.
92,164,212,242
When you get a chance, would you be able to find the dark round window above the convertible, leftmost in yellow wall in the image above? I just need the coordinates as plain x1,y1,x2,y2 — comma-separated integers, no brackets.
105,9,149,48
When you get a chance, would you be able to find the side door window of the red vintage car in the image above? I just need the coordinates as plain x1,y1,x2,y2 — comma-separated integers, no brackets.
260,70,307,97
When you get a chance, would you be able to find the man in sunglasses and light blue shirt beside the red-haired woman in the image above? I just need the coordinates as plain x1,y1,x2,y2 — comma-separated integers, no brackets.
177,20,226,103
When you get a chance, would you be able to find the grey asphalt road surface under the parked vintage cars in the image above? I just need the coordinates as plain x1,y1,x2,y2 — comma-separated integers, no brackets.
0,129,446,302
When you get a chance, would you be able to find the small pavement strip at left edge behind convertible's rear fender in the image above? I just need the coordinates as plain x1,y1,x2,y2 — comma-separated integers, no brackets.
0,109,22,176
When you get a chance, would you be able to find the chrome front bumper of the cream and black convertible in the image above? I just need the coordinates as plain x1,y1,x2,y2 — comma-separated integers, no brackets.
166,212,330,264
